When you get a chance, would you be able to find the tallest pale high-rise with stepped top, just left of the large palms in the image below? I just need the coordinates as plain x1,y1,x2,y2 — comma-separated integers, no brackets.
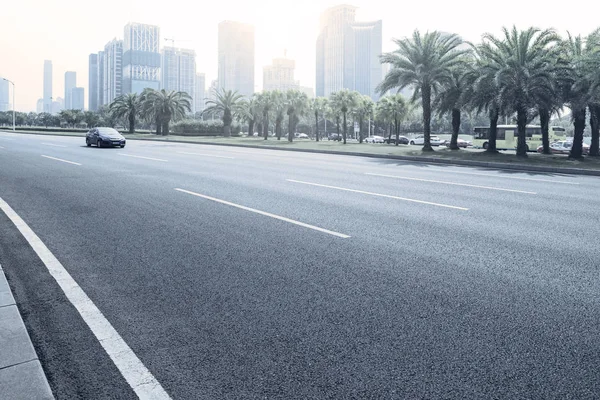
316,5,382,99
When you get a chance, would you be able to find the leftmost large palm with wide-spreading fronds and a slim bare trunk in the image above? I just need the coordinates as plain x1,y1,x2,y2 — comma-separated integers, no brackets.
377,30,468,151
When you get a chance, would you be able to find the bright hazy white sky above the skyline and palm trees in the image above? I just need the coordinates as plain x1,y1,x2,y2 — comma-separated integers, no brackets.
0,0,600,111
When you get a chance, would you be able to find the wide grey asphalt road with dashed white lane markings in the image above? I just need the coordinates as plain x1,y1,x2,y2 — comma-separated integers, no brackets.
0,133,600,399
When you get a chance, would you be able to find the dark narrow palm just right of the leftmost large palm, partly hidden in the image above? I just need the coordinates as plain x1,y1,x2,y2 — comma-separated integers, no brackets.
433,64,474,150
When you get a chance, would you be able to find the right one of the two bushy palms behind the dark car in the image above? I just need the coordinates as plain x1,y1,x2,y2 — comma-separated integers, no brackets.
142,89,192,135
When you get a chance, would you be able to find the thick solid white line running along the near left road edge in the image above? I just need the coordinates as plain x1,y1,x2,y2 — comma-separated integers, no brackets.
0,198,170,400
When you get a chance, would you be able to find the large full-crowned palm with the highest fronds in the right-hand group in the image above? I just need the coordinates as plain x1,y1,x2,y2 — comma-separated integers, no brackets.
484,27,559,157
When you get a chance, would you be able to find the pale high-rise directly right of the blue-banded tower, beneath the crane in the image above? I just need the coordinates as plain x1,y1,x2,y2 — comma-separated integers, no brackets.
161,47,196,110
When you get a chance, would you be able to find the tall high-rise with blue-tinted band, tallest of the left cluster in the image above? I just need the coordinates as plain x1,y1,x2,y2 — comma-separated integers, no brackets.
123,23,161,93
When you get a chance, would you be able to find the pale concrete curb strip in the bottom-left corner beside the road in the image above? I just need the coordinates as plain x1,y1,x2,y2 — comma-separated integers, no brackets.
0,266,54,400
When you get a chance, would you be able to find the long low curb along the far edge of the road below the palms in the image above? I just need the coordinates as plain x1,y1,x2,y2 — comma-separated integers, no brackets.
7,131,600,176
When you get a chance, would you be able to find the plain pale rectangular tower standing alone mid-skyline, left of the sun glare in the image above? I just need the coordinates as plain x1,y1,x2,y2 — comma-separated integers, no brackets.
218,21,254,97
